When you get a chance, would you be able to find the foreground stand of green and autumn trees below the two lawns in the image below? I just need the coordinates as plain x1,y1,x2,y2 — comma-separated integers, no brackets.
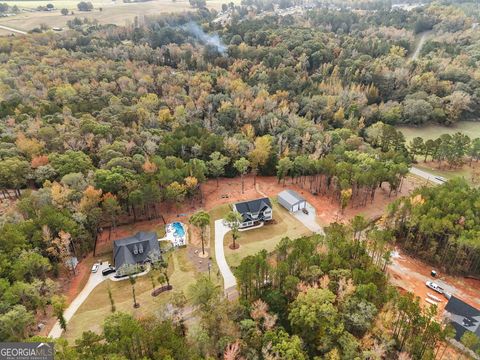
34,226,452,360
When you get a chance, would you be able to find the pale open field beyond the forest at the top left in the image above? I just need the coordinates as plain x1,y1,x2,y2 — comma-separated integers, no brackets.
0,0,234,35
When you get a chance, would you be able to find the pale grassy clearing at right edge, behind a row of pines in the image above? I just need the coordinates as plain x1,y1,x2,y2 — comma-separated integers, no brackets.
397,121,480,144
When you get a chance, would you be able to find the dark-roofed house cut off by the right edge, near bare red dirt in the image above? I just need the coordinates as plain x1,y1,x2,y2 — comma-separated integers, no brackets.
444,295,480,341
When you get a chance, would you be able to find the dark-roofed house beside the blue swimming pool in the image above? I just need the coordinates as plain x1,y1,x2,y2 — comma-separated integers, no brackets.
113,232,161,270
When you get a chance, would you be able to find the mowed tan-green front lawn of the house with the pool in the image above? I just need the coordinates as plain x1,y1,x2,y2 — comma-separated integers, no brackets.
63,248,219,343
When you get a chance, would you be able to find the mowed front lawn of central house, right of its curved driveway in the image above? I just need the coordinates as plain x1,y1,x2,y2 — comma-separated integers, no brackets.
224,201,312,267
